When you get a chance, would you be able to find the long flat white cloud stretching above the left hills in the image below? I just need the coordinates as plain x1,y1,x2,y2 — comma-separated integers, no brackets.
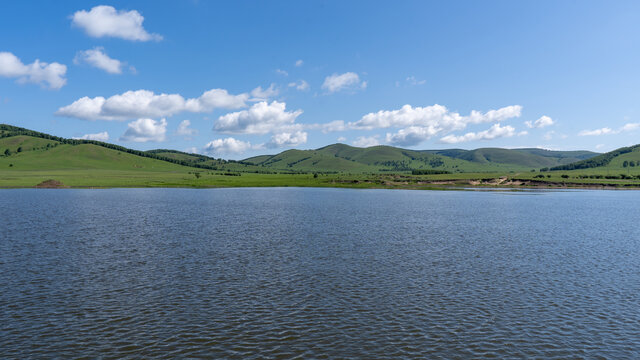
56,89,249,120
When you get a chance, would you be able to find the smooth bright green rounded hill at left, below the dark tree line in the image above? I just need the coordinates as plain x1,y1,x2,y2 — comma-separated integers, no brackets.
0,144,195,172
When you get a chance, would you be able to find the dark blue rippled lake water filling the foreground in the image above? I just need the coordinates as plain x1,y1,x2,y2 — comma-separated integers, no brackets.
0,188,640,359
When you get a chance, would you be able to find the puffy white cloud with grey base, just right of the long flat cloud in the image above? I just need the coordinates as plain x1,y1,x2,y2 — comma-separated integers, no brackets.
213,101,302,134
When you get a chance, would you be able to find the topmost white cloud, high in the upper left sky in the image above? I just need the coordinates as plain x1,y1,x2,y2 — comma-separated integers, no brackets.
71,5,162,41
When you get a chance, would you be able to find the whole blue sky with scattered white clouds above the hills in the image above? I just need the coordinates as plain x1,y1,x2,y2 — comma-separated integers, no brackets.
0,0,640,159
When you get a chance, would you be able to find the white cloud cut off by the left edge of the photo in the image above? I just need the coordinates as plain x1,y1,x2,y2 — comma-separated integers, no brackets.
0,52,67,89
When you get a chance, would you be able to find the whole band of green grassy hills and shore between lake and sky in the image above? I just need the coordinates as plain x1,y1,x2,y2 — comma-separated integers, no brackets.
0,124,640,189
